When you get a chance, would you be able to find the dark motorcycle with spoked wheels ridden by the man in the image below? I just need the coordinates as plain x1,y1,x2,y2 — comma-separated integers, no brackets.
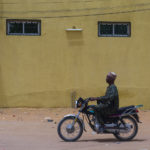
57,98,143,142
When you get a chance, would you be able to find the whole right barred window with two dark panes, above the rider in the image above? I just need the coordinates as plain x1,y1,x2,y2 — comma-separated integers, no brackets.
98,22,131,37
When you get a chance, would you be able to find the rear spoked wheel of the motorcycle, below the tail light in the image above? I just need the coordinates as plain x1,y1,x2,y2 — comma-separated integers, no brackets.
114,116,138,141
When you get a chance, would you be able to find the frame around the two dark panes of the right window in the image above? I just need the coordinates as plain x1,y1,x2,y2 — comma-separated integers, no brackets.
98,21,131,37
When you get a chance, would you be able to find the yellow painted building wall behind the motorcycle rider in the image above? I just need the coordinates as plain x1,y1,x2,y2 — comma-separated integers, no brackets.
0,0,150,109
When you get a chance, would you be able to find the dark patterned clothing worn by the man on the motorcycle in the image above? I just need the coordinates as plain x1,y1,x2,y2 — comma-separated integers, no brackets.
95,84,119,124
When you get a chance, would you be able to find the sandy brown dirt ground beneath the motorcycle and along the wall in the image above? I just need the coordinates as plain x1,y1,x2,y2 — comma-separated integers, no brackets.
0,108,150,150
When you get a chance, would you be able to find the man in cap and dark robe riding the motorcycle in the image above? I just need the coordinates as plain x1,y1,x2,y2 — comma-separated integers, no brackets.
89,72,119,130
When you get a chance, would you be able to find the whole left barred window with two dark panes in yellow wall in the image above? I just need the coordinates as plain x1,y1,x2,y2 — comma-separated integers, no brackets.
7,20,41,35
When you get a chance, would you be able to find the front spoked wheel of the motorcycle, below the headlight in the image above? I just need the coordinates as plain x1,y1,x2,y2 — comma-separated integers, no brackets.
57,116,83,142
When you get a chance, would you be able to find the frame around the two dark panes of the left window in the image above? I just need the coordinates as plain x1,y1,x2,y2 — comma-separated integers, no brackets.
6,19,41,36
